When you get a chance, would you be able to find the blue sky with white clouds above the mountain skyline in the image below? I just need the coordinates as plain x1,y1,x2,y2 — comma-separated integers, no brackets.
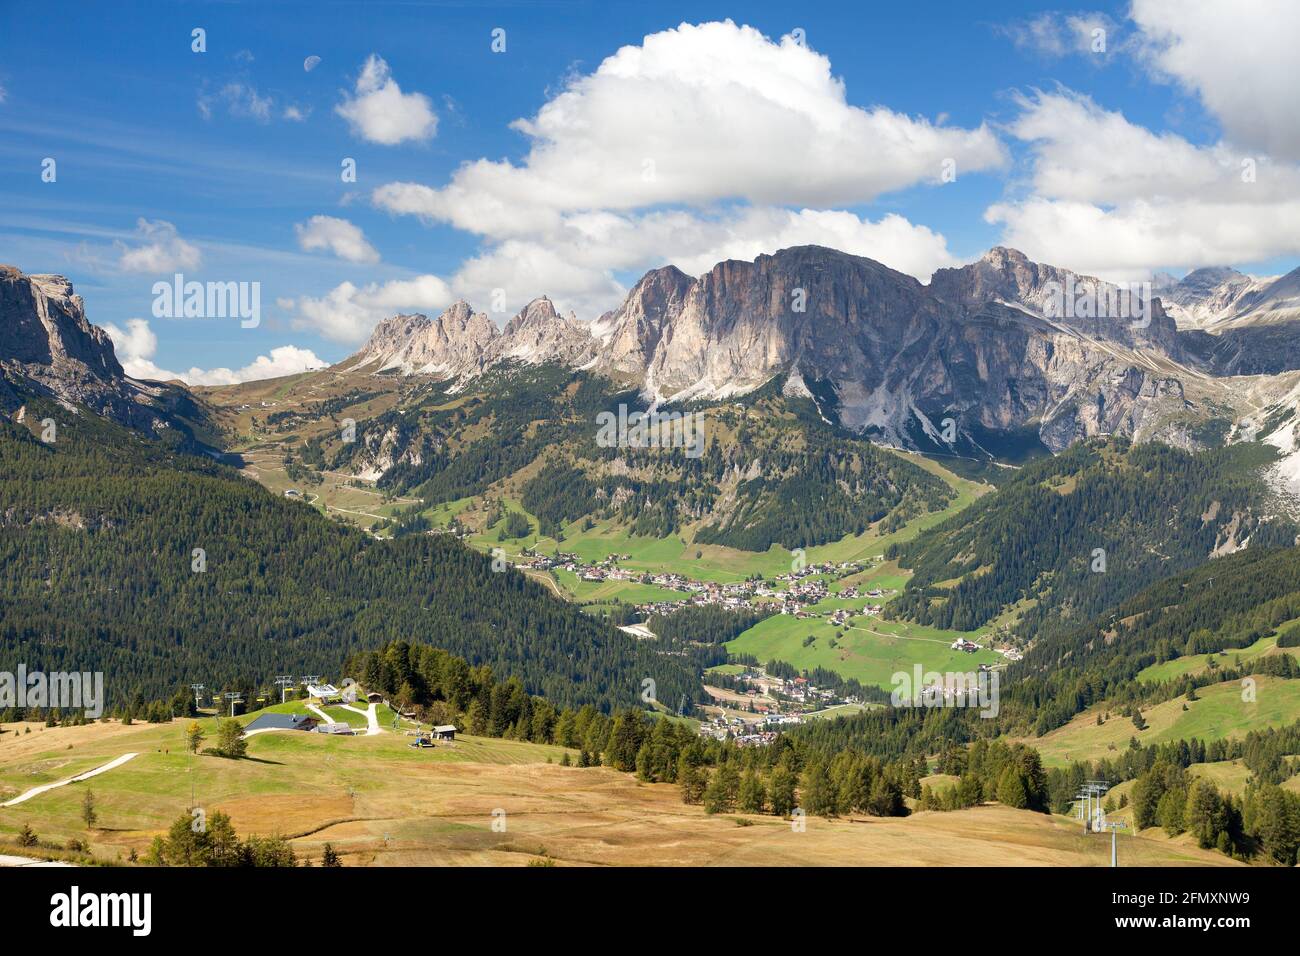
0,0,1300,382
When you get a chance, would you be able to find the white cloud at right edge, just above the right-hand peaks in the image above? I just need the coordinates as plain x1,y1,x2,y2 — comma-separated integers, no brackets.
985,90,1300,280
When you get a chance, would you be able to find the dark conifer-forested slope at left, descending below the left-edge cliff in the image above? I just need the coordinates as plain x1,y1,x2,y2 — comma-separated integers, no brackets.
0,397,698,709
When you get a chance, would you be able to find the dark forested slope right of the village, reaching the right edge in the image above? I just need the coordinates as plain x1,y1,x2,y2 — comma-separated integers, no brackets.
885,438,1296,637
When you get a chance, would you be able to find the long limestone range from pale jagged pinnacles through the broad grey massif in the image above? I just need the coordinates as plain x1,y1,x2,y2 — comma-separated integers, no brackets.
338,246,1268,450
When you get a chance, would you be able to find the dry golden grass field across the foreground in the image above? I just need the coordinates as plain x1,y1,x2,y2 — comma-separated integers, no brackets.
0,721,1231,866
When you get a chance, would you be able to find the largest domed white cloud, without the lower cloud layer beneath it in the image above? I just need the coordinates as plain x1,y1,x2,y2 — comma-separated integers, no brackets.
374,21,1005,230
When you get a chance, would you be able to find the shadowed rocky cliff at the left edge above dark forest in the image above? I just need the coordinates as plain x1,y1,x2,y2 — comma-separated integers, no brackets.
0,265,175,428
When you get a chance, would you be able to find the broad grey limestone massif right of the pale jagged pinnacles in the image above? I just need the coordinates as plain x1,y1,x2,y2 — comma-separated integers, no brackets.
613,247,1184,450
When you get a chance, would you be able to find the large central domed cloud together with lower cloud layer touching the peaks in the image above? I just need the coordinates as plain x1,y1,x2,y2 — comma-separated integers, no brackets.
372,21,1006,317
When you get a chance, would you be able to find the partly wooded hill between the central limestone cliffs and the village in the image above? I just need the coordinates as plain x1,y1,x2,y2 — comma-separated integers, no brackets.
318,364,952,551
